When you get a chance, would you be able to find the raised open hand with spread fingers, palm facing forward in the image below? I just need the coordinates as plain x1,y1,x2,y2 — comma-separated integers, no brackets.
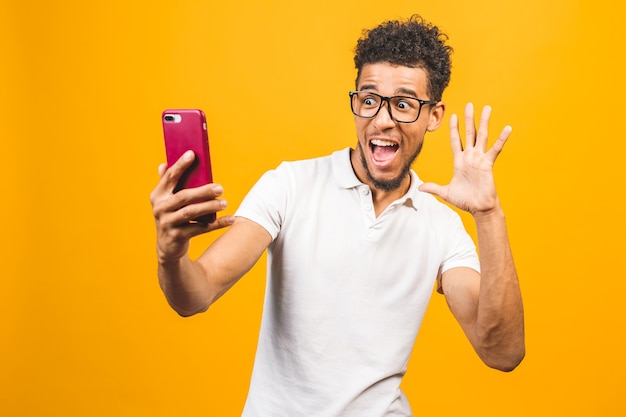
419,103,512,216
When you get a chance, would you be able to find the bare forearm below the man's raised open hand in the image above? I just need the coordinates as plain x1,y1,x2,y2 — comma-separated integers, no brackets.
474,205,525,370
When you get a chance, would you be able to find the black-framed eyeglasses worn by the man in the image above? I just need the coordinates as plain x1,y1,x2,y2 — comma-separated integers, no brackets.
350,91,437,123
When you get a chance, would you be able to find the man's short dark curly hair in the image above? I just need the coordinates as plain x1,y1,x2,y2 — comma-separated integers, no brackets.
354,15,452,101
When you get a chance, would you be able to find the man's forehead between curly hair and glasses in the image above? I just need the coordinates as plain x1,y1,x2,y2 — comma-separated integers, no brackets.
357,62,428,98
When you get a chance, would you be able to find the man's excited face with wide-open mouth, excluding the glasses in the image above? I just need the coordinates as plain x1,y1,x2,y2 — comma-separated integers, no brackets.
352,63,444,192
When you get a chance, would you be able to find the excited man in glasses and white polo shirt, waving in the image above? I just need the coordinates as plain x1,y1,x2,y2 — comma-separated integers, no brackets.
151,17,524,417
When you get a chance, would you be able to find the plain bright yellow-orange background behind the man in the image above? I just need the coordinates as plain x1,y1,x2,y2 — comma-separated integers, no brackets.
0,0,626,417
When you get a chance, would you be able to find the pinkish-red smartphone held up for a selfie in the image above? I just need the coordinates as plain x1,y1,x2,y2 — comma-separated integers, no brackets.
161,109,215,223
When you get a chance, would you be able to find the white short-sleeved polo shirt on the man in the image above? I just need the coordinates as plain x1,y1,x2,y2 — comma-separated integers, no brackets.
236,148,479,417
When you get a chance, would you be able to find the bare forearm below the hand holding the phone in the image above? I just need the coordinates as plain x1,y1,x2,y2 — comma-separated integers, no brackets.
158,255,213,317
